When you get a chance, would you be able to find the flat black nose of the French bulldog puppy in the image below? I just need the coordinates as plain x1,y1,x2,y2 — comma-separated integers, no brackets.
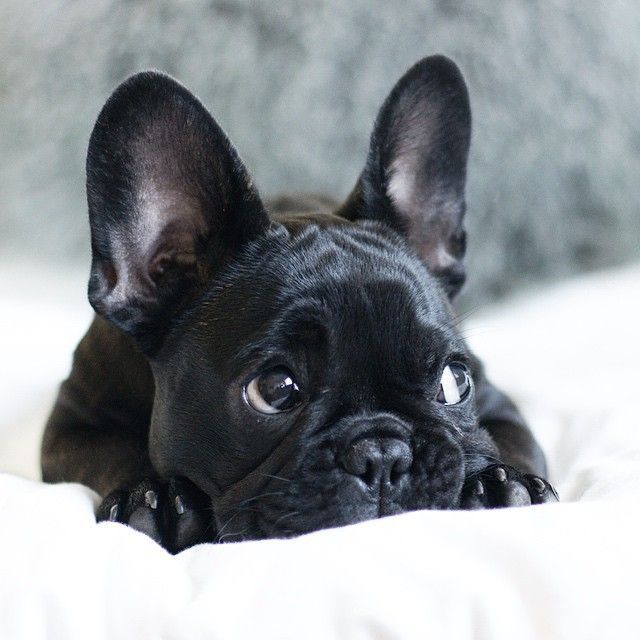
342,438,413,487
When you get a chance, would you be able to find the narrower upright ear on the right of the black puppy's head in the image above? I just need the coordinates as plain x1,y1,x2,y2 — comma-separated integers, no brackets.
338,56,471,297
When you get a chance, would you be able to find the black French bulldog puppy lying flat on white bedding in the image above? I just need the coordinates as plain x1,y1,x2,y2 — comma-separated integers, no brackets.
42,56,557,551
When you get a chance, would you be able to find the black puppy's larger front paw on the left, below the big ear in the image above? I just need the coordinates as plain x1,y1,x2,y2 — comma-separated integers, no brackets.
96,478,213,553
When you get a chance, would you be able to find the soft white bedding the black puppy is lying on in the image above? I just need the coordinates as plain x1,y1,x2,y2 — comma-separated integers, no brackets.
0,267,640,640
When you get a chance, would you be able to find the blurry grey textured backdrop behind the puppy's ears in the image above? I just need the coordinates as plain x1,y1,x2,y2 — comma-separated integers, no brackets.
0,0,640,305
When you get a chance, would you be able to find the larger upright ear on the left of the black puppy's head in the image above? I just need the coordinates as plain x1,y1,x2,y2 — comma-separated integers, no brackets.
87,72,269,352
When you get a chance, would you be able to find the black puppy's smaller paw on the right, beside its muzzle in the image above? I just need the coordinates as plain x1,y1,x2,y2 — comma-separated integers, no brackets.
460,464,559,509
